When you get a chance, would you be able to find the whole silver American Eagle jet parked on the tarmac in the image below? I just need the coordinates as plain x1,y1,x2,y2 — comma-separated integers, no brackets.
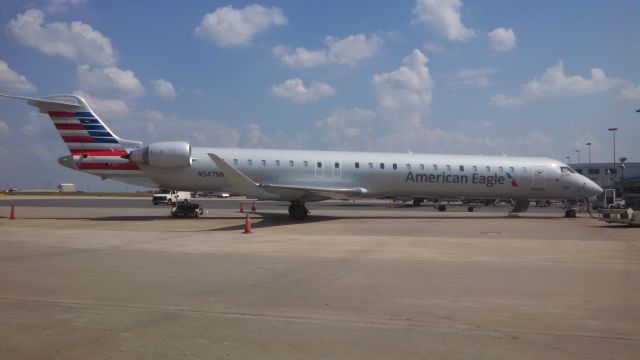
0,95,603,220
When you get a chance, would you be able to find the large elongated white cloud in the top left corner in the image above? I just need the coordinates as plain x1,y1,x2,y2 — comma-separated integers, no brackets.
7,9,116,66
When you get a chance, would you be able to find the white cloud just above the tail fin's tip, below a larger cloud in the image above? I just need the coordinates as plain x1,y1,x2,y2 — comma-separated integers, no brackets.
76,65,144,97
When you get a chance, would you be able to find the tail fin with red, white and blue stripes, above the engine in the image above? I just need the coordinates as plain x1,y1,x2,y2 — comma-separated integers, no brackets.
0,95,142,155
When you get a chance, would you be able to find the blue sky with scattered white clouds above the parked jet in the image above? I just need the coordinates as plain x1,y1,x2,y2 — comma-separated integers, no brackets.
0,0,640,190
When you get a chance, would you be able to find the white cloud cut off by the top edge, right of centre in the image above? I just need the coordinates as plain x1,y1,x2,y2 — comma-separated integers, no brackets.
413,0,475,41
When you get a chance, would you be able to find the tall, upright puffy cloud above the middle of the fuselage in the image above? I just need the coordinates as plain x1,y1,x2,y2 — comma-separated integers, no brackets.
372,49,434,127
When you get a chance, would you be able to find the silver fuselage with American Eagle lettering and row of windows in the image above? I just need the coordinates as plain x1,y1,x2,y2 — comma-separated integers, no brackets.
127,148,589,201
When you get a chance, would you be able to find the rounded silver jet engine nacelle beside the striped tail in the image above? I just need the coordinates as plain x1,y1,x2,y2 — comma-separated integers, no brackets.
128,141,192,168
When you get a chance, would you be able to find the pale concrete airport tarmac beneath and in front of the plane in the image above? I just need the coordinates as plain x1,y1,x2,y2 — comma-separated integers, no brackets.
0,199,640,359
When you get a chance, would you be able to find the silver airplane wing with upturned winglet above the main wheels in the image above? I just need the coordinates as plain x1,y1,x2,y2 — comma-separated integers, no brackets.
208,153,367,201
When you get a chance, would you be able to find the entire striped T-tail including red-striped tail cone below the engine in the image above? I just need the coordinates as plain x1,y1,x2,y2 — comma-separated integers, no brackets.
0,94,152,186
